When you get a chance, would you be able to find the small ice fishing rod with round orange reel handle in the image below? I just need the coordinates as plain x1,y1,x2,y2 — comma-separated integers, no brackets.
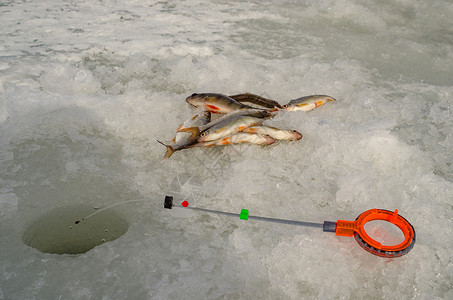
164,196,415,258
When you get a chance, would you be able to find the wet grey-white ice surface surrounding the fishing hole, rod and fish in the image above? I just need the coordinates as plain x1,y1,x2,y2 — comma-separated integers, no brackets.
0,0,453,299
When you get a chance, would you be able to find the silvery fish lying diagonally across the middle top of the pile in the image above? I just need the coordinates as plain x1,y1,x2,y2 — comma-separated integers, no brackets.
198,116,264,143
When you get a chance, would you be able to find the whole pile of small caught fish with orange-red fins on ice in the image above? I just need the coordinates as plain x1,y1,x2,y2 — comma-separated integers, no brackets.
158,93,335,158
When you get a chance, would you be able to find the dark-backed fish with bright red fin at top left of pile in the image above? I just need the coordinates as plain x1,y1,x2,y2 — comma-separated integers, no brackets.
186,93,254,114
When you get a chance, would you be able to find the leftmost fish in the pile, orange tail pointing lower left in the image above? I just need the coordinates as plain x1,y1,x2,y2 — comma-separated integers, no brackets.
158,111,211,159
